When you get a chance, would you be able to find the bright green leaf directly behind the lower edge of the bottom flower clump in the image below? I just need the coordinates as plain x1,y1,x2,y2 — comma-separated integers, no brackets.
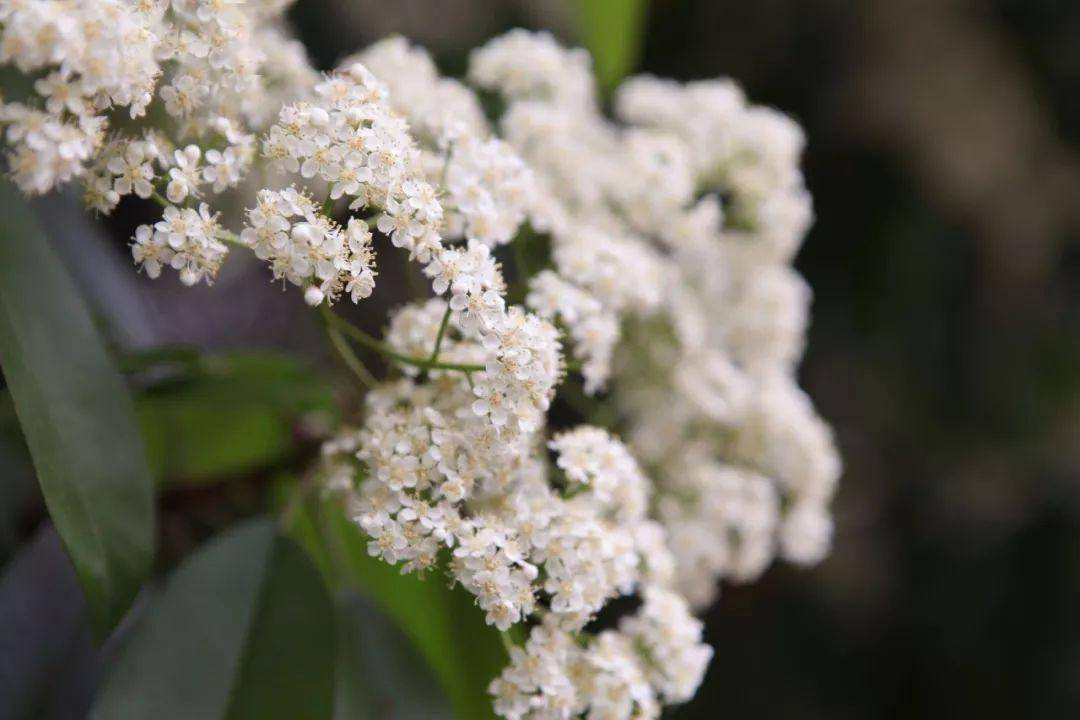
293,502,507,719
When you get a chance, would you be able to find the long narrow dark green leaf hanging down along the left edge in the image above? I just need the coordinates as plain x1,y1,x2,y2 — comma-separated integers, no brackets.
0,182,154,637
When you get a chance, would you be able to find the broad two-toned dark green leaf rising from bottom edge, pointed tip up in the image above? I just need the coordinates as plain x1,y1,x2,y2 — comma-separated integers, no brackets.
91,519,338,720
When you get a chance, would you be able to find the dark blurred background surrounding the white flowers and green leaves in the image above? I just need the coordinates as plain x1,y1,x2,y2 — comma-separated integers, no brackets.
0,0,1080,719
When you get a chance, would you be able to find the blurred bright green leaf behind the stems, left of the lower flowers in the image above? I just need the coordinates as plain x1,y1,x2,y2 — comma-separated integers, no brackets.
136,353,337,484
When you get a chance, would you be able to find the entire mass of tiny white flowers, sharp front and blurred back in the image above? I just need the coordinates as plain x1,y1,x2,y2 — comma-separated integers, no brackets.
0,12,840,719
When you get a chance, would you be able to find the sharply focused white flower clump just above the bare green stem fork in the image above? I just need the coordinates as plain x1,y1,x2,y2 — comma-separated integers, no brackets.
240,64,443,305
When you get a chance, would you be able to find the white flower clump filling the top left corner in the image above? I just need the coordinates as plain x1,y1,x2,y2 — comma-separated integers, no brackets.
0,0,313,204
